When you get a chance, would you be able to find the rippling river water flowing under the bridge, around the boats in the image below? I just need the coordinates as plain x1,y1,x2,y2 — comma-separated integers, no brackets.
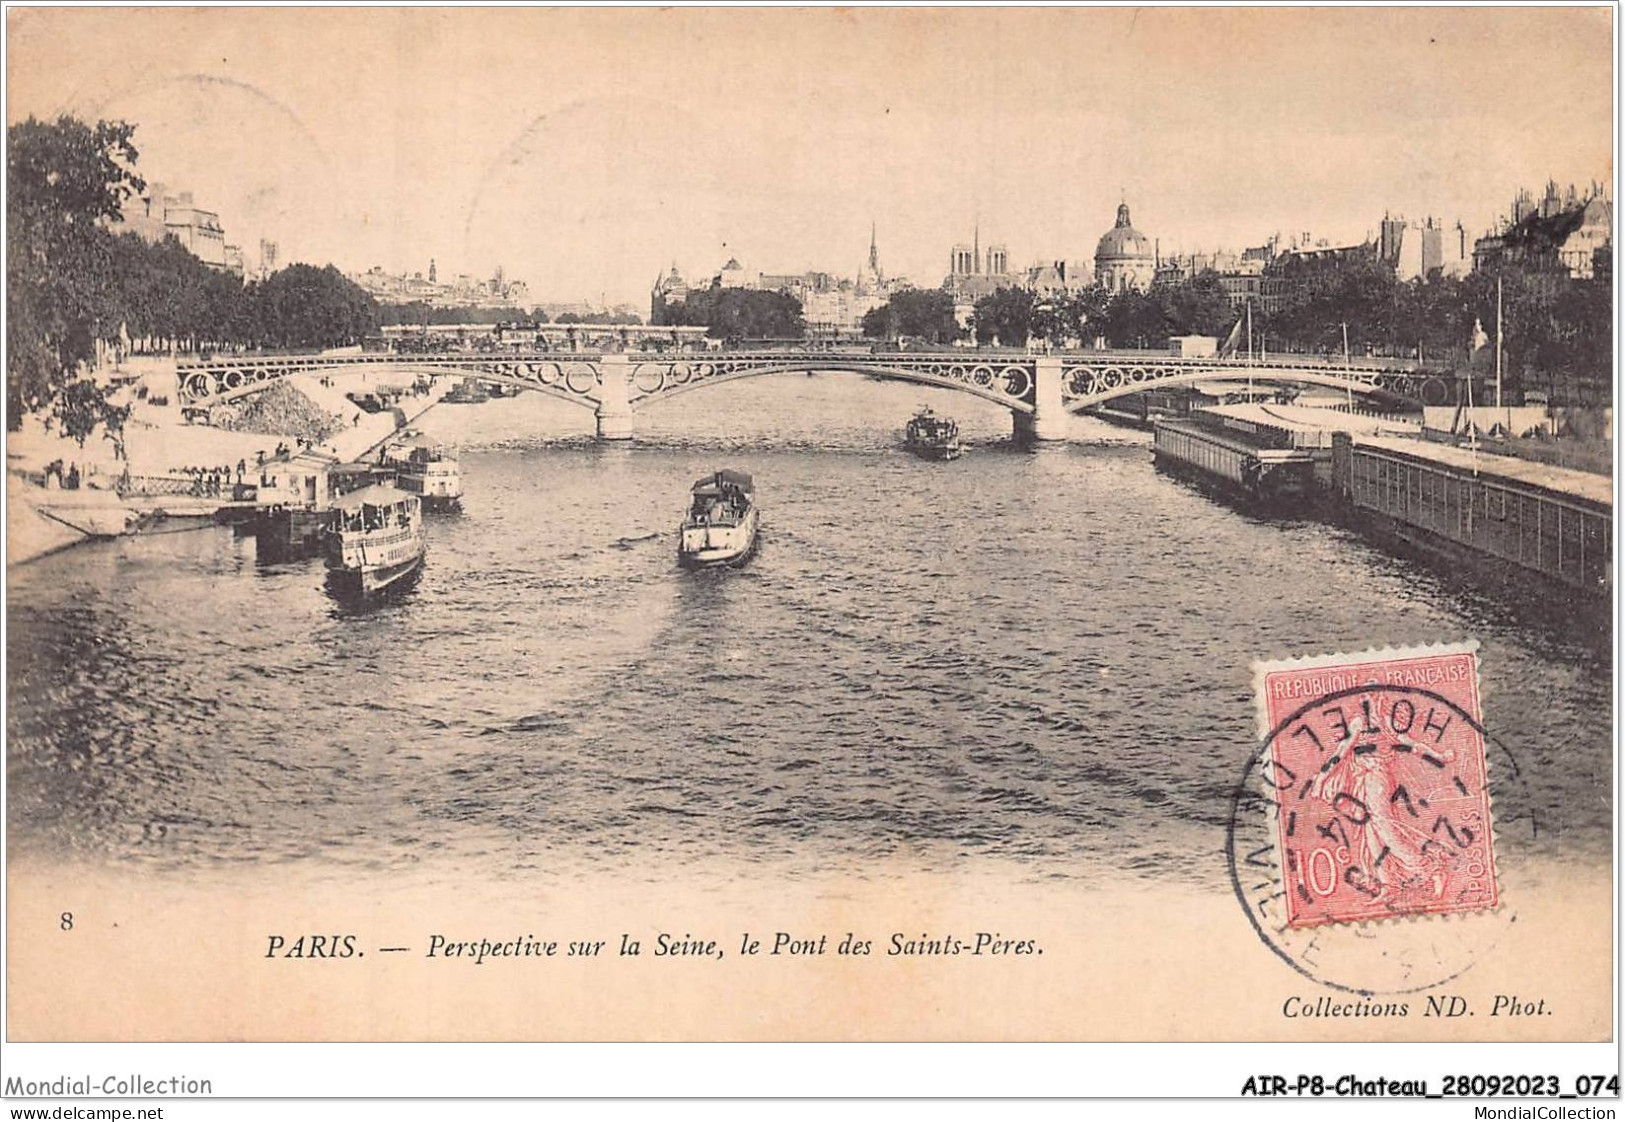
7,376,1612,881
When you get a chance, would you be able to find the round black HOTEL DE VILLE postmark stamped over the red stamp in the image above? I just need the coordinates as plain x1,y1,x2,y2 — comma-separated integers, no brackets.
1225,669,1536,995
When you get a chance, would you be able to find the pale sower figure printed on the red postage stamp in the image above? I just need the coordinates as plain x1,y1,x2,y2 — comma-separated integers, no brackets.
1310,694,1454,899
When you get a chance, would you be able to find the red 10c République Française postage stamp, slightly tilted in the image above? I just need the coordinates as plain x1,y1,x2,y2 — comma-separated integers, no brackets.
1253,644,1500,927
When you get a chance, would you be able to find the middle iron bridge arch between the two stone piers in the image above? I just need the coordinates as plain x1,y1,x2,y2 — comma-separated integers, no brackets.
627,354,1034,413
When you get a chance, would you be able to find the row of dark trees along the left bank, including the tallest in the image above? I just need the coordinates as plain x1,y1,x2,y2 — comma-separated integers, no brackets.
7,117,379,444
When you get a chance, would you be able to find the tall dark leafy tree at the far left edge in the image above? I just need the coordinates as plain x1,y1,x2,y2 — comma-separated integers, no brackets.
7,117,145,442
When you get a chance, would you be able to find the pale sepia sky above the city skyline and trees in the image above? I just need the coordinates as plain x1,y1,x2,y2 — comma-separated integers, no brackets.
7,8,1614,307
